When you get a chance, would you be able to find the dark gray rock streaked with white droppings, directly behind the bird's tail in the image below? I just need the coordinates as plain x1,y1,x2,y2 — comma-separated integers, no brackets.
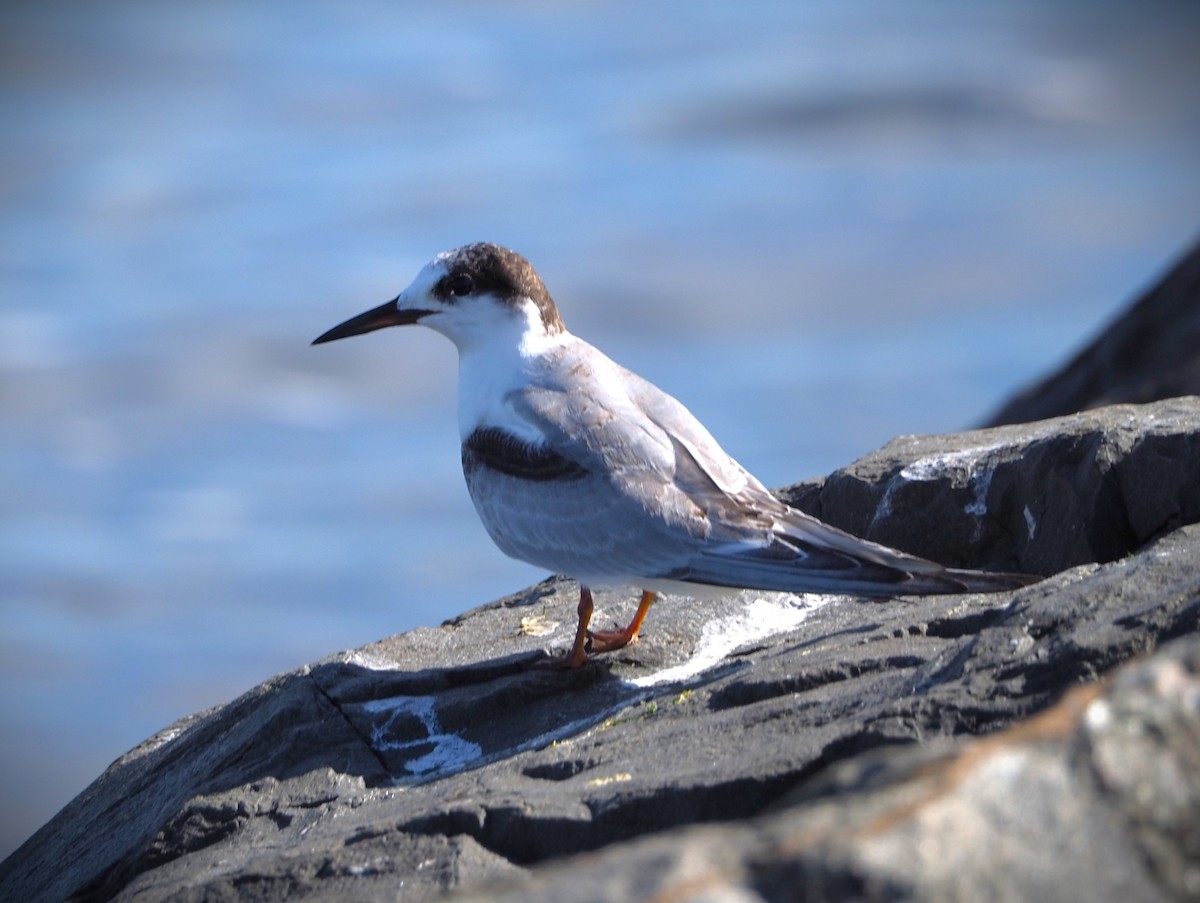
779,397,1200,574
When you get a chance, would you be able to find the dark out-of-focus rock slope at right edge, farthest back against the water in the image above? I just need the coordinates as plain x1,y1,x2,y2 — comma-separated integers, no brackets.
986,236,1200,426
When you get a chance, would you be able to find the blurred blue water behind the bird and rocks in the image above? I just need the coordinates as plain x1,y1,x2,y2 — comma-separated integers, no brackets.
0,0,1200,854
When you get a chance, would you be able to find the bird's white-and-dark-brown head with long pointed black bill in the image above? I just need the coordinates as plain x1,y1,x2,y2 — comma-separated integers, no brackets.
313,241,564,352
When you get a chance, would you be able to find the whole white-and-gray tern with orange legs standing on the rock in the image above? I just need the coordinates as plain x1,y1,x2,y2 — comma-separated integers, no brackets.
312,241,1034,668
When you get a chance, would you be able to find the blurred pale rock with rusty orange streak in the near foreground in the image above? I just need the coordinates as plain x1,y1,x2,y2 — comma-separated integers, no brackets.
456,636,1200,903
